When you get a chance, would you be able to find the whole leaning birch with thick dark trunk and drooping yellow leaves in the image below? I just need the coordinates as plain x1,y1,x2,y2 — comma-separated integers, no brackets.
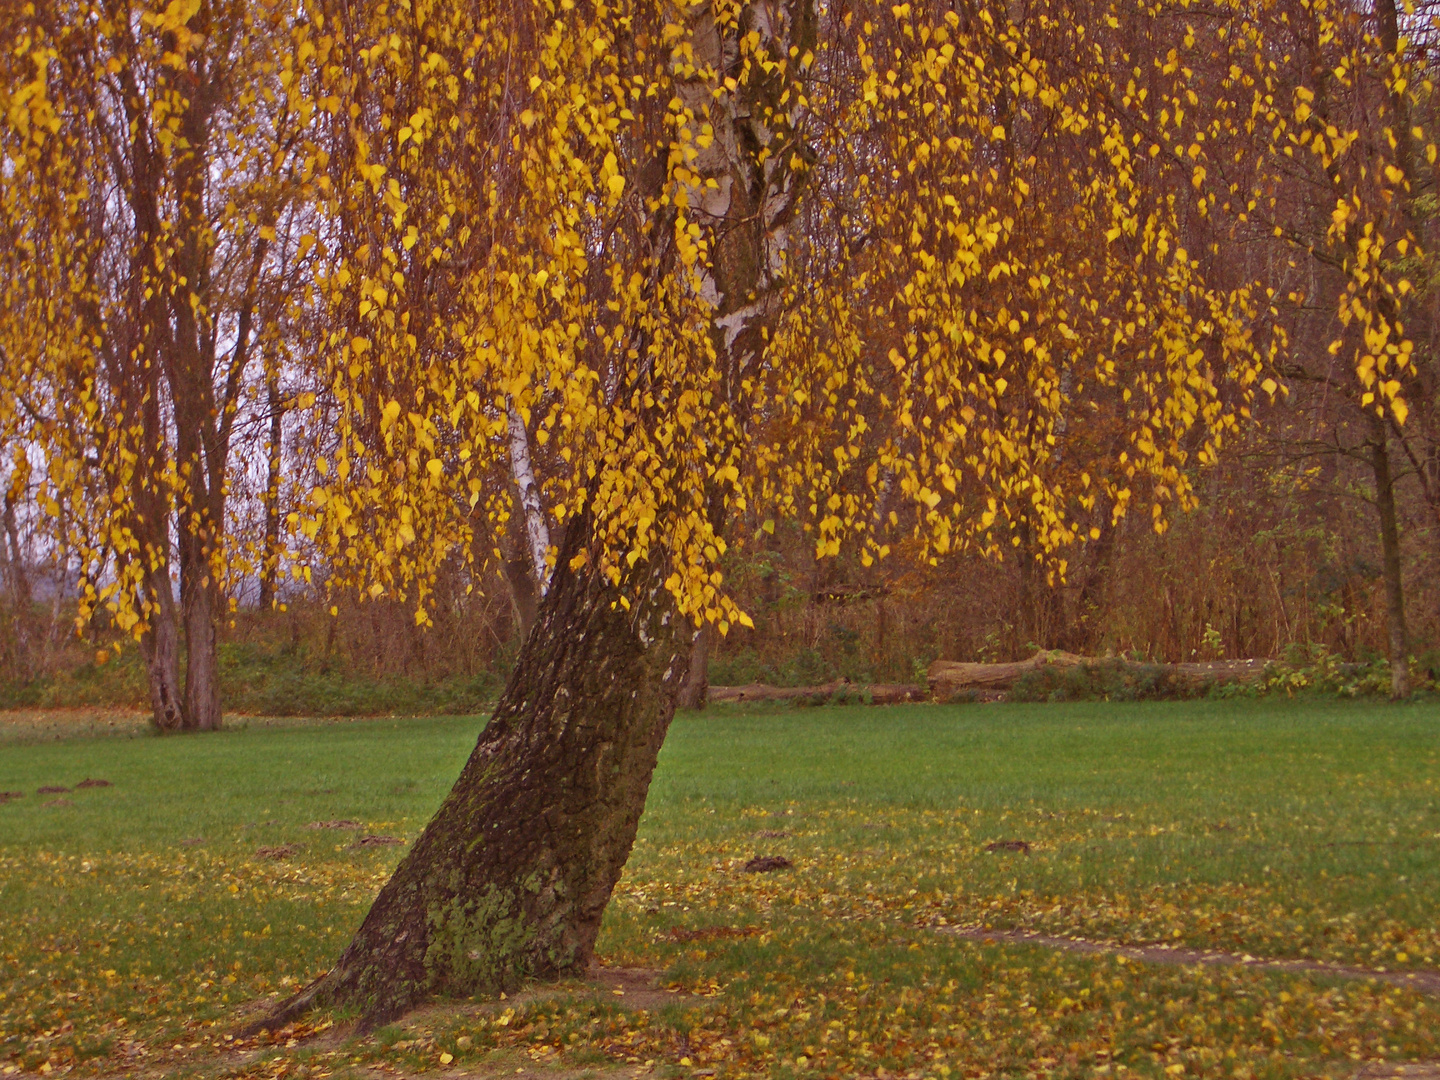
250,0,1264,1027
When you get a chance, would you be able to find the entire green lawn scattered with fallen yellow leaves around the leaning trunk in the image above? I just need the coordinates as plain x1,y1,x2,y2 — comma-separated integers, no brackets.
0,701,1440,1077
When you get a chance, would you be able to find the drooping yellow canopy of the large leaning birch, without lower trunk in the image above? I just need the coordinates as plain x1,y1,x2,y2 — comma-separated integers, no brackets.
275,4,1313,642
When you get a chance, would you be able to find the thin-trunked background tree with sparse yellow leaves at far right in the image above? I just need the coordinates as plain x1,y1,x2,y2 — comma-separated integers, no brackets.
1102,0,1436,697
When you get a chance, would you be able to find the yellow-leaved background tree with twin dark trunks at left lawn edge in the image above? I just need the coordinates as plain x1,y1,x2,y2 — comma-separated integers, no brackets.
0,0,317,730
